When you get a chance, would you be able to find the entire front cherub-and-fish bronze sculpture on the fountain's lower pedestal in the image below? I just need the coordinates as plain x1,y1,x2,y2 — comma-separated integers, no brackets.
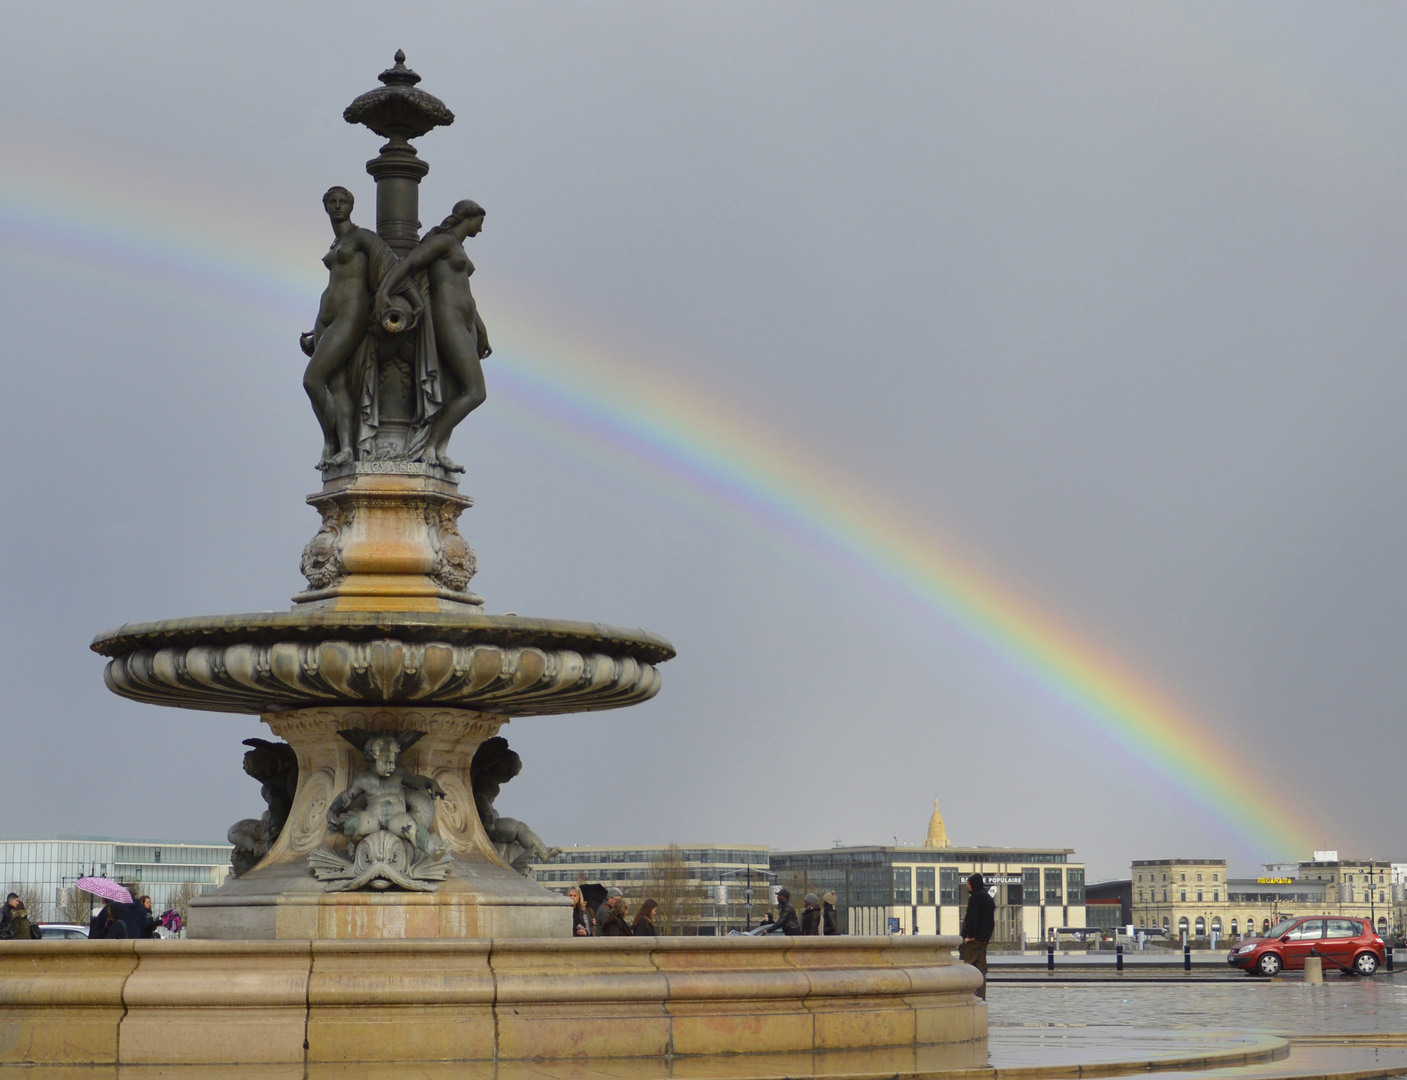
308,730,449,893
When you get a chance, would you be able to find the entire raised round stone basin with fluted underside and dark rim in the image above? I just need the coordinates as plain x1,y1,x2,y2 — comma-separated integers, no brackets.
91,610,674,716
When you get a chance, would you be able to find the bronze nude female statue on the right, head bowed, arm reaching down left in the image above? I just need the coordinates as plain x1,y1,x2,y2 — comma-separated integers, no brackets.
376,198,494,473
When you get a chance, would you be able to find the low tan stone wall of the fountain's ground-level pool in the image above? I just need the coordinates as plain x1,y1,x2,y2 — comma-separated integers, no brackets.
0,938,986,1066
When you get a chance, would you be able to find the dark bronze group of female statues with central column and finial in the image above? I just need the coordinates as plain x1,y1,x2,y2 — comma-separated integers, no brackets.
300,52,492,474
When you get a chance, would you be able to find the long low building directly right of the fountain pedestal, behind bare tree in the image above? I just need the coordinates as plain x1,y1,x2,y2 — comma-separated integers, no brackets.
532,844,772,937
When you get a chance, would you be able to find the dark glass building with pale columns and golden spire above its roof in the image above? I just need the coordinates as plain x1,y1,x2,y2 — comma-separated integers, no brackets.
771,802,1085,944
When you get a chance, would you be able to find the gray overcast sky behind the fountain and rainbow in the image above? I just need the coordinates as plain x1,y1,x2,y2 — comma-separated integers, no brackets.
0,3,1407,878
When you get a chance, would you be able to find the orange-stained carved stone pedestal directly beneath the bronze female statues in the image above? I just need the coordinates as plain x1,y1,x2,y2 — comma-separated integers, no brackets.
293,461,484,612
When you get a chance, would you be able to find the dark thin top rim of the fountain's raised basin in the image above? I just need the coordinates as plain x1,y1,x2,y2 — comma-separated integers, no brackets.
89,610,675,664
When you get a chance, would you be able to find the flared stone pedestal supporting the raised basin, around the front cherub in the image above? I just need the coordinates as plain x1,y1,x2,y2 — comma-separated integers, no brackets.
189,706,571,939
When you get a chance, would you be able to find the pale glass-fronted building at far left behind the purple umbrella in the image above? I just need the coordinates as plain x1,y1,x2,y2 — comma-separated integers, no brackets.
0,837,234,923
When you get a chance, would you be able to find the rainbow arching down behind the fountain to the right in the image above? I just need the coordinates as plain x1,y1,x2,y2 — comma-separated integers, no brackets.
0,162,1323,858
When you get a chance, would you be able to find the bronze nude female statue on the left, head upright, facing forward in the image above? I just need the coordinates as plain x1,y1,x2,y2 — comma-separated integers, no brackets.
300,187,395,467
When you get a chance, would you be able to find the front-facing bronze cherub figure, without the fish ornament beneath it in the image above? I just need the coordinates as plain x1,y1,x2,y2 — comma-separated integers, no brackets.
328,730,445,854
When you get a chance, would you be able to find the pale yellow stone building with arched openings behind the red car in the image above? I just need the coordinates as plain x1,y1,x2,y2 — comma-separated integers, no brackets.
1131,851,1407,941
